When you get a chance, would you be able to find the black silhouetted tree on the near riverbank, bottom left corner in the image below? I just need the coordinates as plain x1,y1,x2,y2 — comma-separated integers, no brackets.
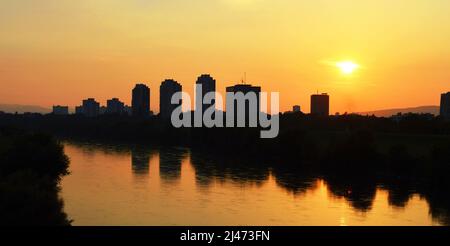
0,128,70,225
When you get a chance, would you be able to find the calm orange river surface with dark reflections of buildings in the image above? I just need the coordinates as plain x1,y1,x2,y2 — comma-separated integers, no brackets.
62,142,450,225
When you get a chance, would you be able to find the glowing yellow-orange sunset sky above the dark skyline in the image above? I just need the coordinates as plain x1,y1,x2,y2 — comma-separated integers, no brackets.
0,0,450,113
